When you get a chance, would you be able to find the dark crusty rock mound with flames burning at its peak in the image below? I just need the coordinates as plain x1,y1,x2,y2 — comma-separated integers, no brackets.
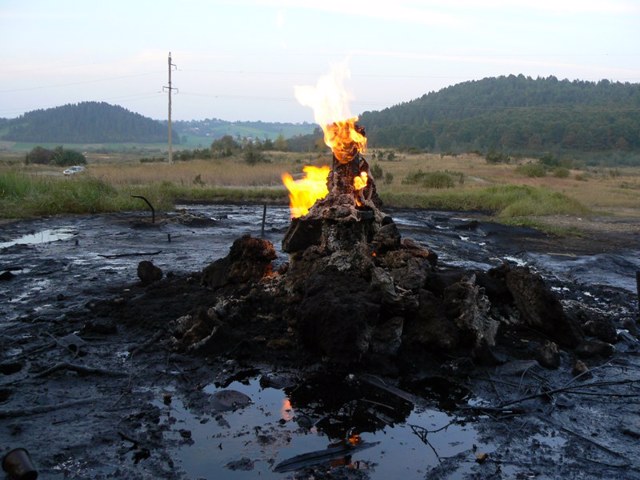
172,155,615,373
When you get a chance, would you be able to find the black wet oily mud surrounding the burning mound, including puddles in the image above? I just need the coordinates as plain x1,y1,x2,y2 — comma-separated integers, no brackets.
0,205,640,479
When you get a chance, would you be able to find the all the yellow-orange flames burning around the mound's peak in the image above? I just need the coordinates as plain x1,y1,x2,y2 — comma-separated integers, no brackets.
282,64,369,218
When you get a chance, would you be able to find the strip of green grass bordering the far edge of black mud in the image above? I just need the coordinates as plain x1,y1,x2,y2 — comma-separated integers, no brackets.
0,169,589,221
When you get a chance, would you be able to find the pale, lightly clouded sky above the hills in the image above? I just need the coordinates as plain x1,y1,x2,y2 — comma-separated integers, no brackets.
0,0,640,122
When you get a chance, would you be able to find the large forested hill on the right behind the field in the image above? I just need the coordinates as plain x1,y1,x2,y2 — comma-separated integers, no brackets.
359,75,640,152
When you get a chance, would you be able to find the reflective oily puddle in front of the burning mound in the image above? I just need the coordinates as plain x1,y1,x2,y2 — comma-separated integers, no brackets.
156,373,494,479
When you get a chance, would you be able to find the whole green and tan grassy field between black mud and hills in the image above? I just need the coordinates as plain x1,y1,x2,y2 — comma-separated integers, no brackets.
0,152,640,232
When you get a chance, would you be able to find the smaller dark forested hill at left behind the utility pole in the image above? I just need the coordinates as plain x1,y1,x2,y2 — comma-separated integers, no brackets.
0,102,179,143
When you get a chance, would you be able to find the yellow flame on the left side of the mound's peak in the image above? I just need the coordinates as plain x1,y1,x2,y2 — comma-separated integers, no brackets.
282,165,330,218
